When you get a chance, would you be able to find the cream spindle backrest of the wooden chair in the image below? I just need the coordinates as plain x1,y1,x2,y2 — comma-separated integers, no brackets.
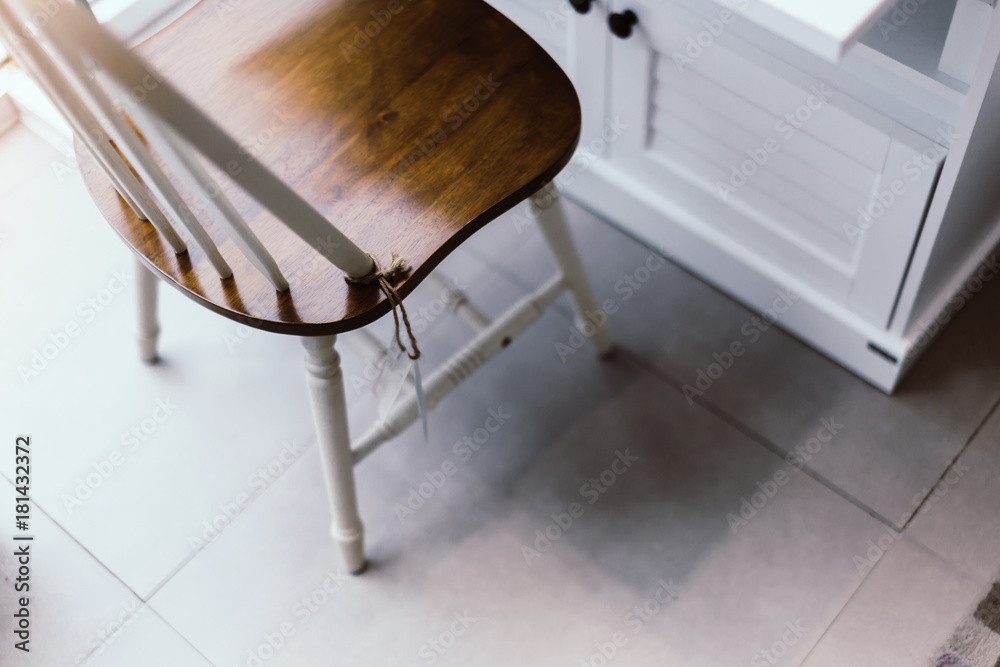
0,0,374,291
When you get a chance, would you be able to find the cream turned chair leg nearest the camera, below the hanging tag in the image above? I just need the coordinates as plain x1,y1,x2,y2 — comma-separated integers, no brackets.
302,336,366,574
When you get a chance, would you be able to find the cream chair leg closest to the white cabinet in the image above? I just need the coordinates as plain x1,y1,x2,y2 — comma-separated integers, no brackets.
531,183,612,357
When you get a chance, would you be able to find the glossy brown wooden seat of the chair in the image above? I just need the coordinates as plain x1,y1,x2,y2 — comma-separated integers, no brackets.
77,0,580,336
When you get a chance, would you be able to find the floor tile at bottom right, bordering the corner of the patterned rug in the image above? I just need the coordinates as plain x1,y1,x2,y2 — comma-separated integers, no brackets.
802,537,988,667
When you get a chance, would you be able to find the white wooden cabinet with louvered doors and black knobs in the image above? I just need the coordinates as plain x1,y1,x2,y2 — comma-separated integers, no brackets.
491,0,1000,391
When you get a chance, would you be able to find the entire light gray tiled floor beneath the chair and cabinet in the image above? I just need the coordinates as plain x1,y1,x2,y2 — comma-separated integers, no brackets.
0,121,1000,667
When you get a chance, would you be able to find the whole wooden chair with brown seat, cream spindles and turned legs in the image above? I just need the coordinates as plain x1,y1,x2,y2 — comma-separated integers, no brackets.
0,0,611,572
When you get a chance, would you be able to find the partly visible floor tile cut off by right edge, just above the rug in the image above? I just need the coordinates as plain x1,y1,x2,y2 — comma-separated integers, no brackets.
907,411,1000,583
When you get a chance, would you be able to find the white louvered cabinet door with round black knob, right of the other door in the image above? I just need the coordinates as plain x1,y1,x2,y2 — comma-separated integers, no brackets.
609,0,947,326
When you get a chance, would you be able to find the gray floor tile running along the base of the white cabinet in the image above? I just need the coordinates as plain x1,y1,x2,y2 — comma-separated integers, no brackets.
540,196,1000,525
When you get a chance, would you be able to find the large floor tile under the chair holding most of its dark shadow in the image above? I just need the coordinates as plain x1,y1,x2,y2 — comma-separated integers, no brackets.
151,316,881,665
